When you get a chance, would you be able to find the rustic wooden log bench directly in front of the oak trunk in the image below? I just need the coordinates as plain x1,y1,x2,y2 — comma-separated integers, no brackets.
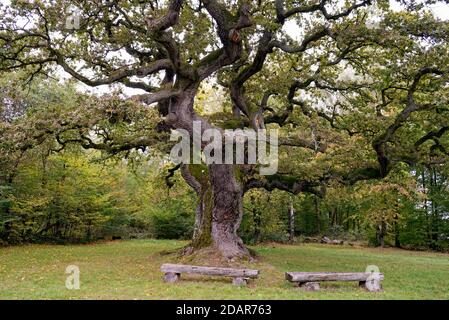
161,263,259,285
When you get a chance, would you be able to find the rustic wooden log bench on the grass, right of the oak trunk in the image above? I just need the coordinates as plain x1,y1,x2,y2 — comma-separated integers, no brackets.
285,272,384,292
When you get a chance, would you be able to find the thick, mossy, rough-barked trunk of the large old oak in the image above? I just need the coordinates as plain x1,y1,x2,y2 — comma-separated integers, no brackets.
171,87,249,259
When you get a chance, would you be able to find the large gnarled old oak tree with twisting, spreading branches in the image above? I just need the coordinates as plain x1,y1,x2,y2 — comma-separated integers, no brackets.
0,0,449,258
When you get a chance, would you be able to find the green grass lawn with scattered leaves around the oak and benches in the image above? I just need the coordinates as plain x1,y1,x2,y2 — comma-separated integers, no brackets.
0,240,449,299
